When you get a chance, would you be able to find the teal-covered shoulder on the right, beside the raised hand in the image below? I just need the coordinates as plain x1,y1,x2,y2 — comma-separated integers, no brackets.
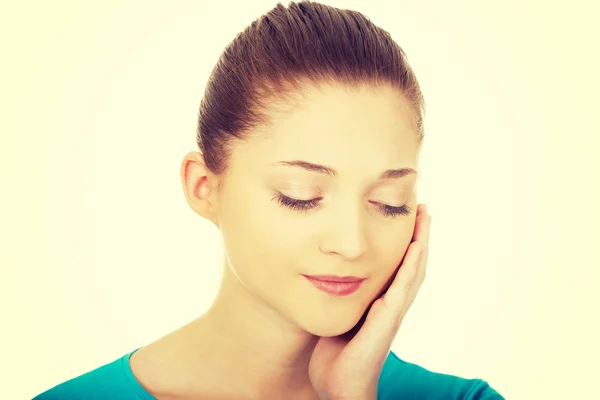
377,352,504,400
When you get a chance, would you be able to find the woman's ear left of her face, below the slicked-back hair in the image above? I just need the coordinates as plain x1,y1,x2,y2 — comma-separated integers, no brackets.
180,151,219,228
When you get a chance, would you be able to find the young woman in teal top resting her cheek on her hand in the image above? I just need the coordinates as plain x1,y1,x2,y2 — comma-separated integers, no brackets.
36,2,502,400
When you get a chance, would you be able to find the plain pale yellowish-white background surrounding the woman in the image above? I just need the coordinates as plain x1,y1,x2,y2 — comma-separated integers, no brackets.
0,0,600,399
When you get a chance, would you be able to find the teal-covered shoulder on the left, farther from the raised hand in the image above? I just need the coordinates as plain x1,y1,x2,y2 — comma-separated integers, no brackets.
33,351,152,400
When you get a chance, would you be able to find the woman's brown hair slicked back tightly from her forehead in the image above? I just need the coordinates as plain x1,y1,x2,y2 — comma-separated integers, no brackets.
196,1,424,175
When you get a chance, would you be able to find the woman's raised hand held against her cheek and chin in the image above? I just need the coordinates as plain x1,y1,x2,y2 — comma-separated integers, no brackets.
309,204,431,400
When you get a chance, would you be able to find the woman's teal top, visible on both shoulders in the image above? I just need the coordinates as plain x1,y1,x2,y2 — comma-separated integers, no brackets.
33,349,505,400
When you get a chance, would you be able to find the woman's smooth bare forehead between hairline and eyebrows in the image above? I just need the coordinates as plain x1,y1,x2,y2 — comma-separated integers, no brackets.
232,85,419,171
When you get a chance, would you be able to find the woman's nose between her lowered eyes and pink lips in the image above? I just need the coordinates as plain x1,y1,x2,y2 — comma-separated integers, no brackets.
319,200,368,260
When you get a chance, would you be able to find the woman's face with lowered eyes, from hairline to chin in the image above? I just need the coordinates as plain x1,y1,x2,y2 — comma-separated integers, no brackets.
211,86,419,336
